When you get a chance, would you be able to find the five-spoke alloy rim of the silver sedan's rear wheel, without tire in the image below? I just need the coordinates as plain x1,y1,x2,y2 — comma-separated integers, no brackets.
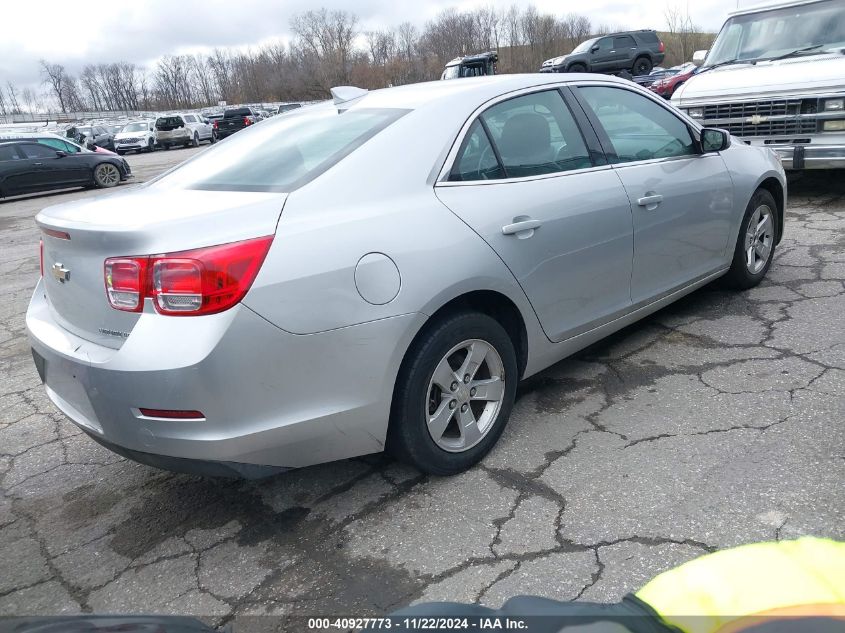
425,339,505,453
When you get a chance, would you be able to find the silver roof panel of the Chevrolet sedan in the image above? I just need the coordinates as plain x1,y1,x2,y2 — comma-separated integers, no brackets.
342,73,634,110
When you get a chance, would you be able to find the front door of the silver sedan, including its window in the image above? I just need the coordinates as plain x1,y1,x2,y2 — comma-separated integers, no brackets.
575,84,733,306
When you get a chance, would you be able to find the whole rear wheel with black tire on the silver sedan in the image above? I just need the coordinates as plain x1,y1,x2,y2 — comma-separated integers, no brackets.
387,312,519,475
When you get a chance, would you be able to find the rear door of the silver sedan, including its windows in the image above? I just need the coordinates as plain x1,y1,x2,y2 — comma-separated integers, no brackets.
435,89,633,341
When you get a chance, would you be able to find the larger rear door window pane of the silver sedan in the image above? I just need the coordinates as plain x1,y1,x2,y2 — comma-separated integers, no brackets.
481,90,592,178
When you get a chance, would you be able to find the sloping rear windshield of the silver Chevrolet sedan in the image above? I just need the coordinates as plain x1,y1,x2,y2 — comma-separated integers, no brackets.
156,103,407,192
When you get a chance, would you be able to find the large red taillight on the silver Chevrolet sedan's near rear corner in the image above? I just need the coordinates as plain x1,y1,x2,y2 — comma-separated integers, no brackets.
105,236,273,316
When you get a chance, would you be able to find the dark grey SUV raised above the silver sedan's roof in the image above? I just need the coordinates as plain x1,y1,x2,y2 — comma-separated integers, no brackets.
540,30,666,76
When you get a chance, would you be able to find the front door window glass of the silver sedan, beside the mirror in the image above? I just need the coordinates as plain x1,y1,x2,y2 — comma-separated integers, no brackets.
578,86,696,163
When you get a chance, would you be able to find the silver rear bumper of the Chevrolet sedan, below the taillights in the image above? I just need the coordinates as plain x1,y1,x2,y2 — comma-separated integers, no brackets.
26,282,423,476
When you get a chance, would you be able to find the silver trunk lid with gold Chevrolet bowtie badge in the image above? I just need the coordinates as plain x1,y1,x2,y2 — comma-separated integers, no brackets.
36,187,286,349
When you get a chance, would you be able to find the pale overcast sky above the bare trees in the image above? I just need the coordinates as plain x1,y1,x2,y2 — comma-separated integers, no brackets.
0,0,740,88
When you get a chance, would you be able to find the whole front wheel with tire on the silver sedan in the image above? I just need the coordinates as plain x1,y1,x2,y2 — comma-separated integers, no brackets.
724,189,778,290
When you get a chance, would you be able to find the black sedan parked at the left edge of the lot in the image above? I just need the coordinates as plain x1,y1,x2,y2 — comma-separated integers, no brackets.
0,138,132,197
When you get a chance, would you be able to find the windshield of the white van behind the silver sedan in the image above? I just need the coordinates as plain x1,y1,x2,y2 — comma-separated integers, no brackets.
704,1,845,67
